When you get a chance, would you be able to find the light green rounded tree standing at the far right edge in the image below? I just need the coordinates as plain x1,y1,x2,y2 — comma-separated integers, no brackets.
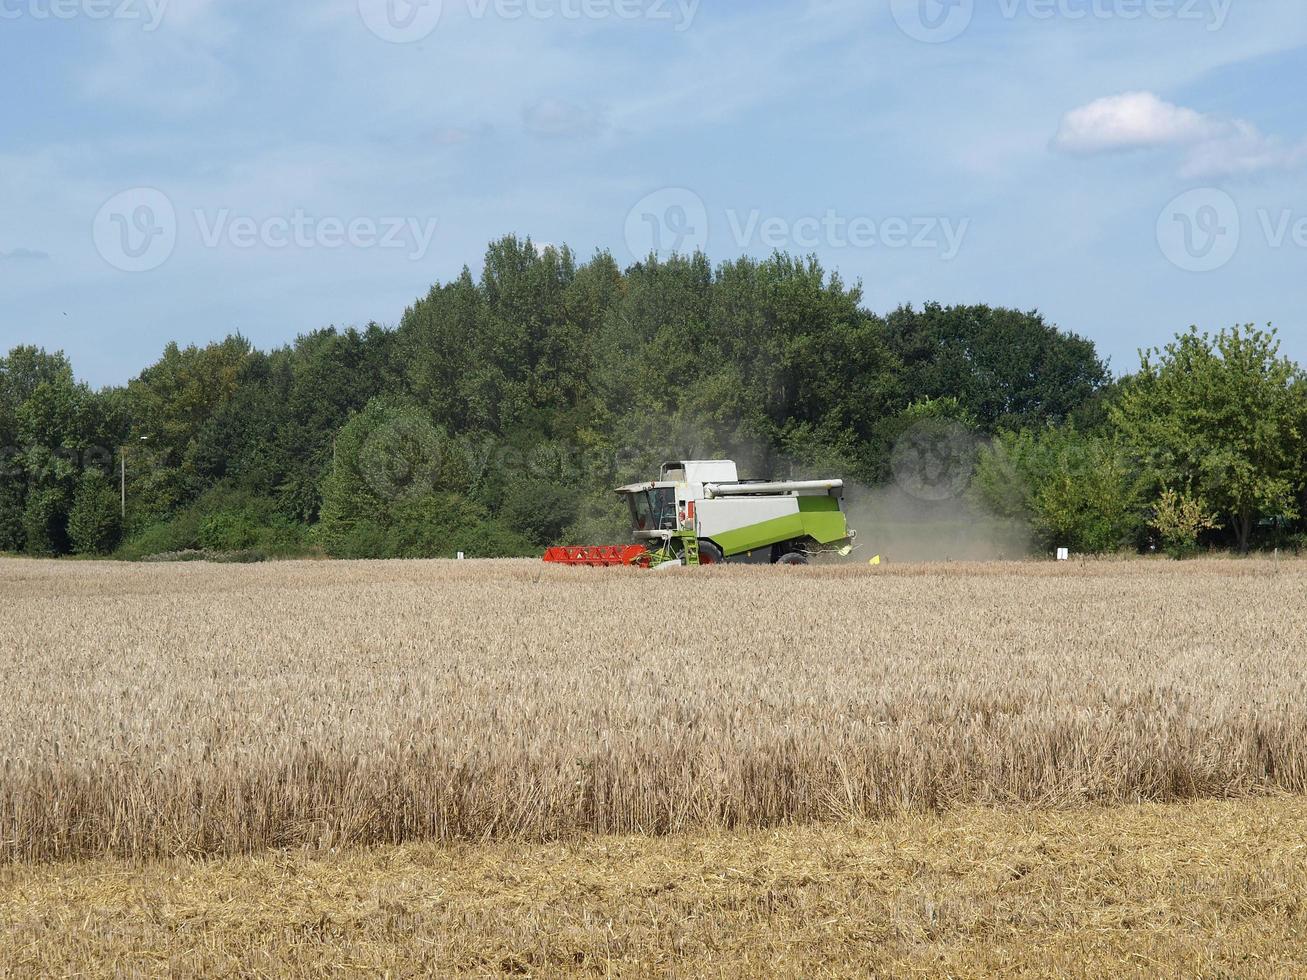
1110,324,1307,551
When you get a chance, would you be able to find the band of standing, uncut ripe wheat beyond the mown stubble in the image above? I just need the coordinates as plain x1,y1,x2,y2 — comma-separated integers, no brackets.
0,561,1307,865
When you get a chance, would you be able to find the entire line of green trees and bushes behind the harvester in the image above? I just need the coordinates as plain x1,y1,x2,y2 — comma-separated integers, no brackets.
0,237,1307,558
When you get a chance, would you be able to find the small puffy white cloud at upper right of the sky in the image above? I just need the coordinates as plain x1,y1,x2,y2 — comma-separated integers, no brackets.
1053,91,1307,178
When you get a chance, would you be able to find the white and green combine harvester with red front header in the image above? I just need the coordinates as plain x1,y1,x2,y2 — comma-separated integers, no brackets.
545,460,857,568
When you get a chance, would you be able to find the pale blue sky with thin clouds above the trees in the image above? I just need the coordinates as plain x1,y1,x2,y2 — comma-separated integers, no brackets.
0,0,1307,385
